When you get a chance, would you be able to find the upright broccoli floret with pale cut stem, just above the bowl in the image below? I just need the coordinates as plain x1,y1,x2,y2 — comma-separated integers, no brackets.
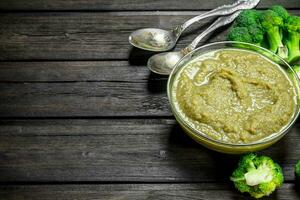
260,10,287,59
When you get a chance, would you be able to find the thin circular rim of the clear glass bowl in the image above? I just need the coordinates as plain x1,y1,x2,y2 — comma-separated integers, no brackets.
167,41,300,147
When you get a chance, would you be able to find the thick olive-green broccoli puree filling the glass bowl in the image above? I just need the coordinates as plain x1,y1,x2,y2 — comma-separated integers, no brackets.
172,49,296,143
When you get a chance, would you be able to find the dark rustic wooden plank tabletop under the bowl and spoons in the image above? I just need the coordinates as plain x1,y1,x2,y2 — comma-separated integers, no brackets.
0,0,300,200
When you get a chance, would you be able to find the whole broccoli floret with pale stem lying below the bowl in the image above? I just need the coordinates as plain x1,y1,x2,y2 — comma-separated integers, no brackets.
230,153,284,198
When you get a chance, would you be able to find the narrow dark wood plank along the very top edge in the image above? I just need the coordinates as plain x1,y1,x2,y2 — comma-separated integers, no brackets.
0,0,300,11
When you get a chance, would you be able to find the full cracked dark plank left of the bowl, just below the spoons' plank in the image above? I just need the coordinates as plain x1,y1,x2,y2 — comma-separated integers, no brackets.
0,61,171,117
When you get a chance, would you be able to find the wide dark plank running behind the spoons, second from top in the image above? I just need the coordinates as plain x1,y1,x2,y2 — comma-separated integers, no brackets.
0,10,300,62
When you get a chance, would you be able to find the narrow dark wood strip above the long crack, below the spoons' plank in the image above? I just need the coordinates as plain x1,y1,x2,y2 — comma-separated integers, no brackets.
0,61,150,83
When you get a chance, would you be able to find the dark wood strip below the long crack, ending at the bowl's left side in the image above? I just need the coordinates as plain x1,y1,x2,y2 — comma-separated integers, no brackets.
0,81,171,117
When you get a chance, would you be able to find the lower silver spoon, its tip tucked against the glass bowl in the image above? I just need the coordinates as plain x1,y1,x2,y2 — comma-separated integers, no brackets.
147,11,241,75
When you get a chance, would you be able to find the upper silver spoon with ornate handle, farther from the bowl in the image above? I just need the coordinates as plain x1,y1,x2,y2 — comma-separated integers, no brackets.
129,0,260,52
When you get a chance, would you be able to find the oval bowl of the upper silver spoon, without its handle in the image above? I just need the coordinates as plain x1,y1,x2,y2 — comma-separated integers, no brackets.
129,28,178,52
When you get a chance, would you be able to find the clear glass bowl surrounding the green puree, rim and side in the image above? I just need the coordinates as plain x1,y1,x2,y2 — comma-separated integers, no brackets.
167,41,299,154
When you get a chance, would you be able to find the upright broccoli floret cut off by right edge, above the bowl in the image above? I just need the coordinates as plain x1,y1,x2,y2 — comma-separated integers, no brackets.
284,16,300,63
